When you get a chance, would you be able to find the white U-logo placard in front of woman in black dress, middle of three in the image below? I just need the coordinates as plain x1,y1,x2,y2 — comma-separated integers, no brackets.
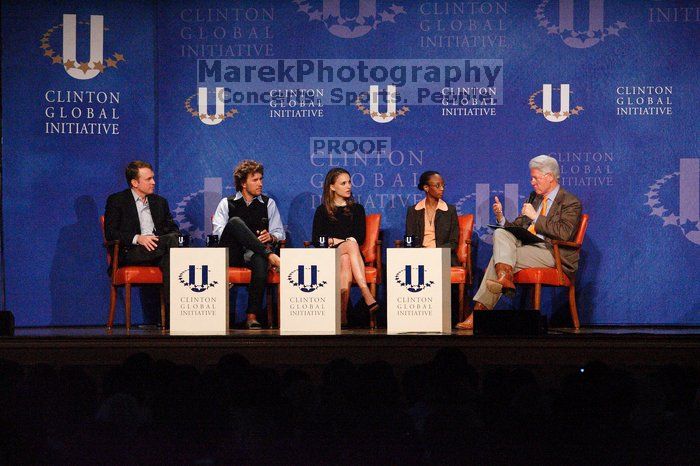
280,248,340,335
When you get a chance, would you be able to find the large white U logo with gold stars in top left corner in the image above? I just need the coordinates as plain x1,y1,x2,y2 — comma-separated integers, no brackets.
39,14,126,80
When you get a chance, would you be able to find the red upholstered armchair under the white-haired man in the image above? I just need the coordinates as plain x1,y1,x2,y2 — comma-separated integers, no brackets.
513,214,588,330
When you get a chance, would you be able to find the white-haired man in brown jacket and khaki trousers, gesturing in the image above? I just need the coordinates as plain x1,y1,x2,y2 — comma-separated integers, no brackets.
457,155,581,329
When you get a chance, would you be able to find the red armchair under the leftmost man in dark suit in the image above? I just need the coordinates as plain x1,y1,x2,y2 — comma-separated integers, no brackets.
100,215,166,330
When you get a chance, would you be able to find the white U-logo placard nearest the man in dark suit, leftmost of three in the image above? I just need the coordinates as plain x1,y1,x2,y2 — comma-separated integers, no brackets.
170,248,229,335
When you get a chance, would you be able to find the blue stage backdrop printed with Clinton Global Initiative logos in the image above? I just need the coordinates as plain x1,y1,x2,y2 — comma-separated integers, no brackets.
2,0,700,326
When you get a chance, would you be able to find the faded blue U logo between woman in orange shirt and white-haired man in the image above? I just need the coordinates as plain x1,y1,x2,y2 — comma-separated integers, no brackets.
455,183,525,244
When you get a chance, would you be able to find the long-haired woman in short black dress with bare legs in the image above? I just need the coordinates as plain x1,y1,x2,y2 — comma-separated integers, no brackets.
313,168,379,324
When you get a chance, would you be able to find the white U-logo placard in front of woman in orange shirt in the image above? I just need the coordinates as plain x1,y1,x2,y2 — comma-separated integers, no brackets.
386,248,452,333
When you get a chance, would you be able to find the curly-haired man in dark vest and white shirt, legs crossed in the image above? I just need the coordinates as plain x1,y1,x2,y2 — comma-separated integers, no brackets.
212,160,285,330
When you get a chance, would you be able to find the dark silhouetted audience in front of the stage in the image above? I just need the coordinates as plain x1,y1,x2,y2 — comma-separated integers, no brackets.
0,354,700,464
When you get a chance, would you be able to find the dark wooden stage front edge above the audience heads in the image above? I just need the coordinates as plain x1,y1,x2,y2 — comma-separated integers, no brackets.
0,327,700,372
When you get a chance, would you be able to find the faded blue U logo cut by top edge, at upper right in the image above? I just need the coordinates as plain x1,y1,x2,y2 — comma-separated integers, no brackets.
535,0,627,49
